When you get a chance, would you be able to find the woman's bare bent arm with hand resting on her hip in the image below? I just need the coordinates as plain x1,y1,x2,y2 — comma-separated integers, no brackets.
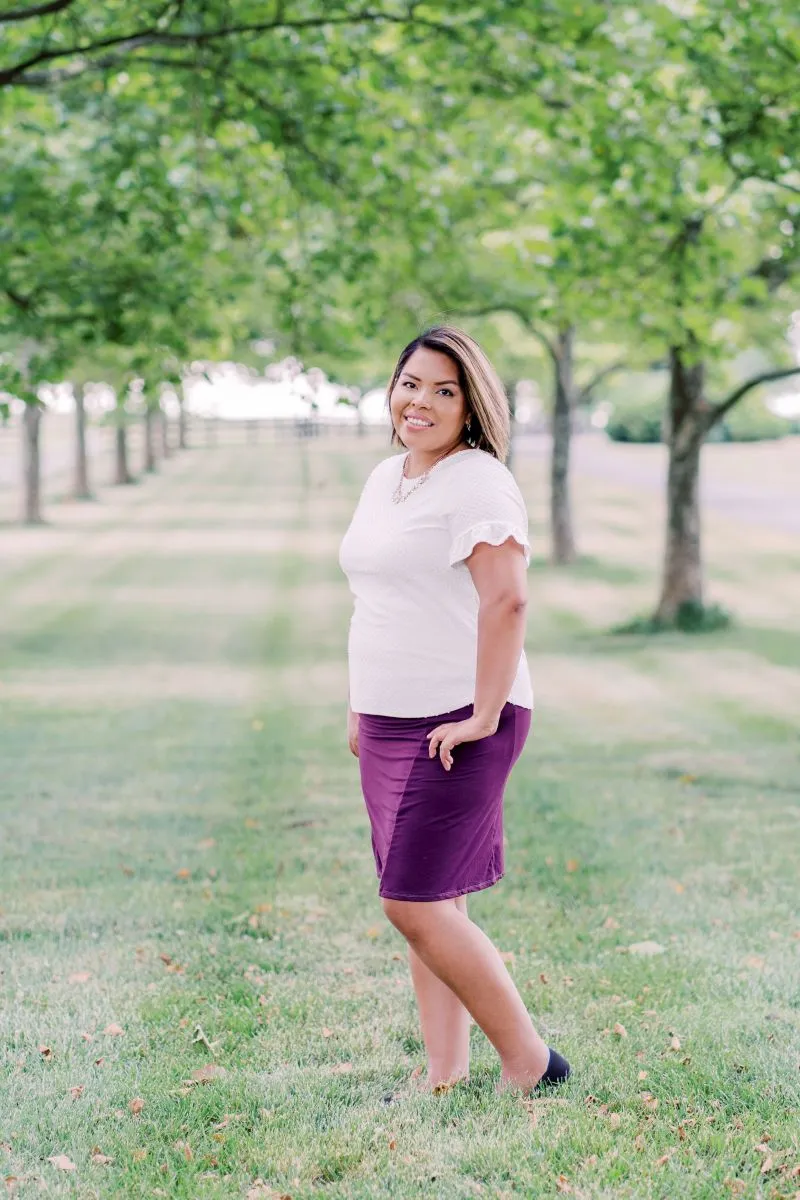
428,538,528,770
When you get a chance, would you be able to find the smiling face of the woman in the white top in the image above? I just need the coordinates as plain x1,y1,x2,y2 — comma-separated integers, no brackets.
389,346,468,456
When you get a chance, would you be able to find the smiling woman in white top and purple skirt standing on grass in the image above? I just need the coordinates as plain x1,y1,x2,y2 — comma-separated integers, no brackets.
339,326,570,1091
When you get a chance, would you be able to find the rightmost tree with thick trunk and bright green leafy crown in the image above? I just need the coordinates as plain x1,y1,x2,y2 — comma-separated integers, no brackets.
578,7,800,626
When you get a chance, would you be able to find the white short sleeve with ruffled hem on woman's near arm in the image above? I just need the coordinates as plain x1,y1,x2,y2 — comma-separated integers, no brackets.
450,463,530,566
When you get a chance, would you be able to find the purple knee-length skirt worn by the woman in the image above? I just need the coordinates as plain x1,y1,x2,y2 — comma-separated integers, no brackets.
359,702,531,901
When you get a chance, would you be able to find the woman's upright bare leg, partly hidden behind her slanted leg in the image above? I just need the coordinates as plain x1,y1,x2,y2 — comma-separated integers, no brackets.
408,896,471,1088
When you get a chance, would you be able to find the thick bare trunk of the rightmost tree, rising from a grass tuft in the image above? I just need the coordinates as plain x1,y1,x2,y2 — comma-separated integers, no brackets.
656,347,708,624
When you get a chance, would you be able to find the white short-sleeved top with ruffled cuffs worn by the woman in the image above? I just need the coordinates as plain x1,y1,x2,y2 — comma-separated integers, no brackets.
339,449,534,716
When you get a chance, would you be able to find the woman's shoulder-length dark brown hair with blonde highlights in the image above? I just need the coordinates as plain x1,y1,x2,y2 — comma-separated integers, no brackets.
386,325,511,462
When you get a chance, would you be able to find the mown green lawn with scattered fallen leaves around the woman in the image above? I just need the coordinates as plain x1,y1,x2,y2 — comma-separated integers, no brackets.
0,442,800,1200
